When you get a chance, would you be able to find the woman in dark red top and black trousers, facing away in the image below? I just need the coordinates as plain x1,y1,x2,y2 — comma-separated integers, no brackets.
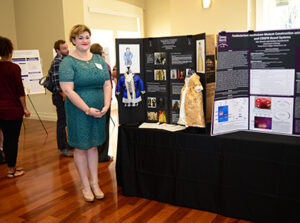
0,36,30,178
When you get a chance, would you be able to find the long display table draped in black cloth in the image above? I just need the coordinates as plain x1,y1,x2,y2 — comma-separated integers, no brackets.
116,126,300,222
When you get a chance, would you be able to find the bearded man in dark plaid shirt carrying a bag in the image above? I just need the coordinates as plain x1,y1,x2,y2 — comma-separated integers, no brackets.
49,40,73,157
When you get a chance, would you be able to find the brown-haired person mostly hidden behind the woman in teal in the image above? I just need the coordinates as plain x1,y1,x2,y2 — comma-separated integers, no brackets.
90,43,113,162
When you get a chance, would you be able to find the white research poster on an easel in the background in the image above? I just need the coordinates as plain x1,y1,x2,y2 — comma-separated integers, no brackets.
12,50,45,94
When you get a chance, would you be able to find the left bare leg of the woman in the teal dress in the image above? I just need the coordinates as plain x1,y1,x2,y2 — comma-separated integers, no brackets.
74,148,93,196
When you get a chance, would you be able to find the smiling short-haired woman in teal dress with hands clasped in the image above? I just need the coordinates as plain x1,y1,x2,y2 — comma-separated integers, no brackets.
59,25,111,202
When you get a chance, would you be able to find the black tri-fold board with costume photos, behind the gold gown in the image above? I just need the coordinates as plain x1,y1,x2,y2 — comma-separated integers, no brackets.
116,33,215,124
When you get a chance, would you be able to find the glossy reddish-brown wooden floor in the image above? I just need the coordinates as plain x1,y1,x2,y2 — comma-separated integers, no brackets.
0,120,253,223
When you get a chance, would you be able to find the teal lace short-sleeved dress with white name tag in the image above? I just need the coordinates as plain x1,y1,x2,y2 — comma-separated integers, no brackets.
59,54,109,149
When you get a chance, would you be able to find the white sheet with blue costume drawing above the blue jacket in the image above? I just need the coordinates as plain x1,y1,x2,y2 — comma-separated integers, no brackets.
119,44,140,74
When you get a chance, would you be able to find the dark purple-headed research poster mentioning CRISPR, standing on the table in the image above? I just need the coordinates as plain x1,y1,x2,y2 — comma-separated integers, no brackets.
211,29,300,135
